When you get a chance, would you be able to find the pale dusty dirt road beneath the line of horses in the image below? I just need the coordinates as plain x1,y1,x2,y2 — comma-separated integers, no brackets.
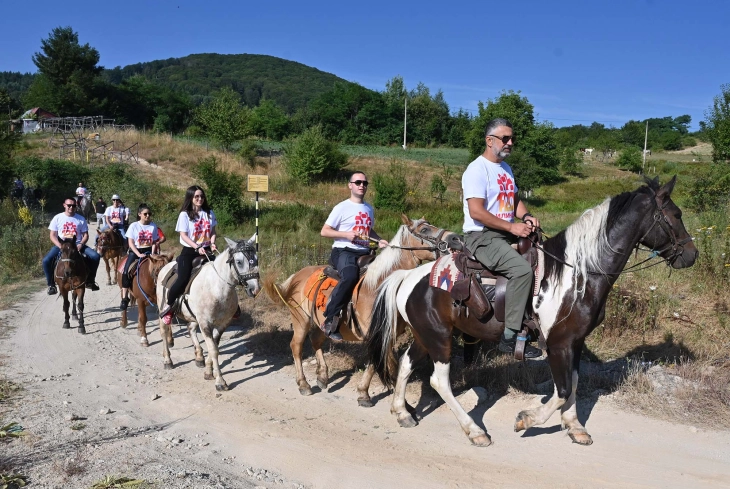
0,265,730,489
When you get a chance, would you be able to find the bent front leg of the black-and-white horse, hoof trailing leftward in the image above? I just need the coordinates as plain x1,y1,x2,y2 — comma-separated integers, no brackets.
515,346,573,431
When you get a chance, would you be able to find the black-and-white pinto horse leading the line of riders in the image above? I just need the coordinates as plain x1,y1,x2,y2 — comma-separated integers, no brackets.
368,177,697,446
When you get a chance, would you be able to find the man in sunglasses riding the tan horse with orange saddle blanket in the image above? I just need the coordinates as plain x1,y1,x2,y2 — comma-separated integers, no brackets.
320,171,388,341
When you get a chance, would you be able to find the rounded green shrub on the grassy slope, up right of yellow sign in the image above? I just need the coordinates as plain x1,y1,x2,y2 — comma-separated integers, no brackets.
283,125,347,183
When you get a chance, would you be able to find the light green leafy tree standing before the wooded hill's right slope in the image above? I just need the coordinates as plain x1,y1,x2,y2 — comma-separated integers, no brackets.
195,87,250,149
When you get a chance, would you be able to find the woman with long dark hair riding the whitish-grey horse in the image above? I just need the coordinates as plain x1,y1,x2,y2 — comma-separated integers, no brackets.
160,185,218,324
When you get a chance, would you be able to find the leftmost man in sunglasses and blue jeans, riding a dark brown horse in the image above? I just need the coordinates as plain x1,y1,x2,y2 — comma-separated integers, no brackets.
43,198,100,295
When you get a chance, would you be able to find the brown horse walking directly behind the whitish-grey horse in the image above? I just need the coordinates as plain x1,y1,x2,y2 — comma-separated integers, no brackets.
117,254,172,346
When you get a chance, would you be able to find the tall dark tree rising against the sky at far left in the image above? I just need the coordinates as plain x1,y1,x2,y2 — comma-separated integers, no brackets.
26,27,103,115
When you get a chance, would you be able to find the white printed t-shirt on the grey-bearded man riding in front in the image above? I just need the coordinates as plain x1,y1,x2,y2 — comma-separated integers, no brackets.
461,155,517,233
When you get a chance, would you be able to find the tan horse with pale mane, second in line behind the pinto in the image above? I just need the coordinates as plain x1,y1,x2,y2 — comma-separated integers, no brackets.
265,215,451,407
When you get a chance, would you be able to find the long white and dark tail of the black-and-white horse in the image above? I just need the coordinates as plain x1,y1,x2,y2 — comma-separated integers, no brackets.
365,270,410,387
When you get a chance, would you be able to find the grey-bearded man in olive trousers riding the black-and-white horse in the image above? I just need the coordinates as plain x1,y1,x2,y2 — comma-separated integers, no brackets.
461,118,542,358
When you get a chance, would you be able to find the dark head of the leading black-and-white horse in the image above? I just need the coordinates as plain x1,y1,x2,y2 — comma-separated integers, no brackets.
639,175,699,268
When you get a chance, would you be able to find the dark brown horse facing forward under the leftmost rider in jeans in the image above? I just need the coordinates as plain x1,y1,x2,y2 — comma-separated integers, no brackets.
55,239,88,334
